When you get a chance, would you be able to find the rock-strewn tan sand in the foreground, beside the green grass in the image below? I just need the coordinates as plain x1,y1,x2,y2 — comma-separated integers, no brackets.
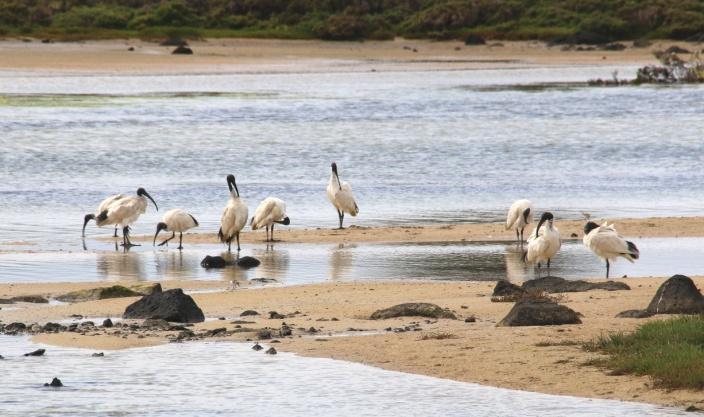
0,277,704,407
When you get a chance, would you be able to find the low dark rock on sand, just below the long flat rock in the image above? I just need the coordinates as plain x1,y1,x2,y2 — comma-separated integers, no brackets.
498,299,582,326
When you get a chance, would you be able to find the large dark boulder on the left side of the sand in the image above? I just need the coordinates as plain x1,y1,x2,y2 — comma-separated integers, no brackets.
122,288,205,323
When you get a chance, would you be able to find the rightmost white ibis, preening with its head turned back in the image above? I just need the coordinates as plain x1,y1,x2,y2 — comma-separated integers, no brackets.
582,222,640,279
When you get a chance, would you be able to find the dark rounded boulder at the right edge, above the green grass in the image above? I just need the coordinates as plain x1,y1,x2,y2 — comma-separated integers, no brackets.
646,275,704,314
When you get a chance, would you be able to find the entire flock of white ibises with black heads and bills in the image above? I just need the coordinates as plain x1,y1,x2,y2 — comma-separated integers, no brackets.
82,162,639,278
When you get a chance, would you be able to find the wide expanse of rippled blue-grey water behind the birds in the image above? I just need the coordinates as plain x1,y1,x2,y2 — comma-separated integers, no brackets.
0,67,704,247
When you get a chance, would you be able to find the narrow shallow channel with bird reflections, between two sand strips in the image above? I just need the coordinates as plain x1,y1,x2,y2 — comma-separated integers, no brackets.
0,238,704,285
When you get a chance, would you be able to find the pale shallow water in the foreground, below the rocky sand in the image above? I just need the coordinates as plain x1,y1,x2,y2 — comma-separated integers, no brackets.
0,336,686,417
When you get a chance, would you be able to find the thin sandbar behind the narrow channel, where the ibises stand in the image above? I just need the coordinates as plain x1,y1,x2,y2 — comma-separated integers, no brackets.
119,217,704,244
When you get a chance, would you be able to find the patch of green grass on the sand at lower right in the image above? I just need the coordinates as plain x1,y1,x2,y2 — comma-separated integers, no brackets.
585,316,704,389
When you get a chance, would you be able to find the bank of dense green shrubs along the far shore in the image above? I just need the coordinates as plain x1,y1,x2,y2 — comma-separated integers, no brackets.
0,0,704,43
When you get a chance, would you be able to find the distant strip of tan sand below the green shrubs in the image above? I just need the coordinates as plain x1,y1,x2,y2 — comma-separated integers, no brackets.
0,39,680,74
